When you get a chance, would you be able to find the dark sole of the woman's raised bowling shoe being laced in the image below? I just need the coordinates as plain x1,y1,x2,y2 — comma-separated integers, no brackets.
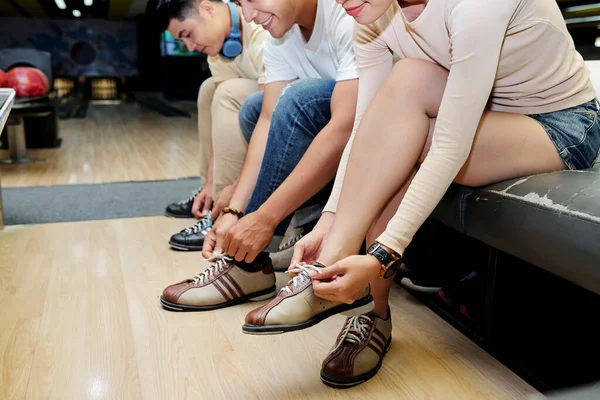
242,295,375,335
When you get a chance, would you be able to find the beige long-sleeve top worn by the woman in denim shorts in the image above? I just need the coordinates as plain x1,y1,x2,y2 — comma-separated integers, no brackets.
325,0,595,254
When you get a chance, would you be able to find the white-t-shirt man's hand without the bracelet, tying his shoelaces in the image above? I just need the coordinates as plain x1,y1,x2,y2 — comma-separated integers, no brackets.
223,210,277,262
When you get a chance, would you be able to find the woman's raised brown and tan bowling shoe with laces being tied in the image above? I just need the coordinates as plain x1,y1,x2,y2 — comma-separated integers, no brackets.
242,264,374,335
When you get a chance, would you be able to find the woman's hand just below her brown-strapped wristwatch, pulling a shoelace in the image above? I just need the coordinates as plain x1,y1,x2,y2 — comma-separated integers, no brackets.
310,255,381,304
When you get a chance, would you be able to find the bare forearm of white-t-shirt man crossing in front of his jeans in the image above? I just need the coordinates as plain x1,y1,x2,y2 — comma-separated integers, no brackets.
259,122,350,224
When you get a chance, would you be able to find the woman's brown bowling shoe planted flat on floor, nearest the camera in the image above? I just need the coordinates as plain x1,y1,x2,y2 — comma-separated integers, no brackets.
321,309,392,388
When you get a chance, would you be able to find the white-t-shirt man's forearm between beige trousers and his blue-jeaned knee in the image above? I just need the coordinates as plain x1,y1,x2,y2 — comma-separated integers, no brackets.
230,115,271,210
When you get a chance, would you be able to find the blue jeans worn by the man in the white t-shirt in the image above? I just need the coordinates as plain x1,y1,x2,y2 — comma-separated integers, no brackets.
239,79,335,242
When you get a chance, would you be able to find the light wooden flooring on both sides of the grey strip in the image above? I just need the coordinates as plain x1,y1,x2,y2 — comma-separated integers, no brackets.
0,105,535,400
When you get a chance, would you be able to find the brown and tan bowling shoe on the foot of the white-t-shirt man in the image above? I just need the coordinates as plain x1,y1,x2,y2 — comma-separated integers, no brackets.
160,256,277,311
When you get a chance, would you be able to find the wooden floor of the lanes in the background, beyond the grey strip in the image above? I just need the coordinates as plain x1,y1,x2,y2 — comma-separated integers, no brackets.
0,103,199,187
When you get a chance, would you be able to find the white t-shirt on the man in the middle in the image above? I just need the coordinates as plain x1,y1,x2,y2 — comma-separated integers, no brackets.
263,0,358,84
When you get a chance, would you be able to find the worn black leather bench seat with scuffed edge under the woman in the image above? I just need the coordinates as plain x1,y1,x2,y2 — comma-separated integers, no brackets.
432,164,600,294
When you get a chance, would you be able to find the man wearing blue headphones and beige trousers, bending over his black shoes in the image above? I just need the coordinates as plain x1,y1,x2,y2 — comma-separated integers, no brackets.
146,0,267,251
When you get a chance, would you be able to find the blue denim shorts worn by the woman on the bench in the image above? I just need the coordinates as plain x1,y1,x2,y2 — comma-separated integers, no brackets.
529,99,600,169
